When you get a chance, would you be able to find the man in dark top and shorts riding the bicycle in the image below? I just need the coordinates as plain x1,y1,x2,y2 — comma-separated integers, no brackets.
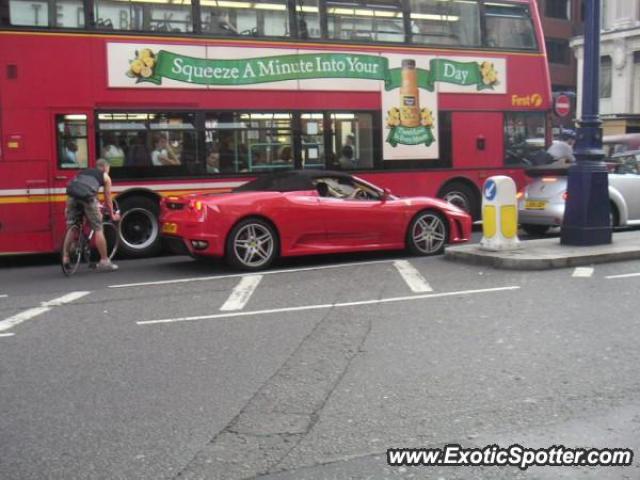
62,158,120,272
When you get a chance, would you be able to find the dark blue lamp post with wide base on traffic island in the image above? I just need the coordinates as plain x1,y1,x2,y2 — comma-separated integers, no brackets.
560,0,611,246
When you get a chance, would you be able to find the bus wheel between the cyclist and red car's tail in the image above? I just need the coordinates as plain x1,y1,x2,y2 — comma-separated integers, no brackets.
119,197,162,257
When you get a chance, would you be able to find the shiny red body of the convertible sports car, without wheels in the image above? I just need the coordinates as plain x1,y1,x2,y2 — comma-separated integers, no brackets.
160,171,471,264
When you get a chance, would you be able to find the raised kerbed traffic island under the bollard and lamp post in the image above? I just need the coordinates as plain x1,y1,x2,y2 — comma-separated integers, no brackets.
445,231,640,270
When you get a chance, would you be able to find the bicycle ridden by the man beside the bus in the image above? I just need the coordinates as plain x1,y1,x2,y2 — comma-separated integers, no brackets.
60,201,120,277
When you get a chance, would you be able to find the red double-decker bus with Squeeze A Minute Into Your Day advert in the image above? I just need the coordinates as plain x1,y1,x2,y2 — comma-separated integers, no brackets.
0,0,551,256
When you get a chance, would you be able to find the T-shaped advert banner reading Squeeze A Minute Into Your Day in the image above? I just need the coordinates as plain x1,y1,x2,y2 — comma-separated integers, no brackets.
107,43,507,160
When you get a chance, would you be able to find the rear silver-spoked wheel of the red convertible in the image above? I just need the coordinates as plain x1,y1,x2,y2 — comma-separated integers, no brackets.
226,218,279,271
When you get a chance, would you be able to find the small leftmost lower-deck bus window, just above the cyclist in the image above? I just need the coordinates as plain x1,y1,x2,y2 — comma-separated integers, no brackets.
56,114,89,168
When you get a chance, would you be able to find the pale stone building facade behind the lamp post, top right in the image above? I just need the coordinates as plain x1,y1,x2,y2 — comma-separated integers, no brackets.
571,0,640,135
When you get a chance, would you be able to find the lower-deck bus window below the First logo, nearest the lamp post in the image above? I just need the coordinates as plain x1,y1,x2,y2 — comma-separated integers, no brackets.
504,112,545,165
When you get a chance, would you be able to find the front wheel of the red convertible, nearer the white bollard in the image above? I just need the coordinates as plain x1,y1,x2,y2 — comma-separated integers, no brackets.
407,210,449,255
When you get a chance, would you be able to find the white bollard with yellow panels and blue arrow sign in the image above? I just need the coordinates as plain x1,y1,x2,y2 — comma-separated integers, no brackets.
480,175,520,251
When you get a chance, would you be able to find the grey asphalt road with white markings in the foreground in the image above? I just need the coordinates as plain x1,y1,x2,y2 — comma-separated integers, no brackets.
0,232,640,480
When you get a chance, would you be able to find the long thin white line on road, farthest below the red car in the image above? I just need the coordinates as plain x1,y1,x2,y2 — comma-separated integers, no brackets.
136,286,520,325
